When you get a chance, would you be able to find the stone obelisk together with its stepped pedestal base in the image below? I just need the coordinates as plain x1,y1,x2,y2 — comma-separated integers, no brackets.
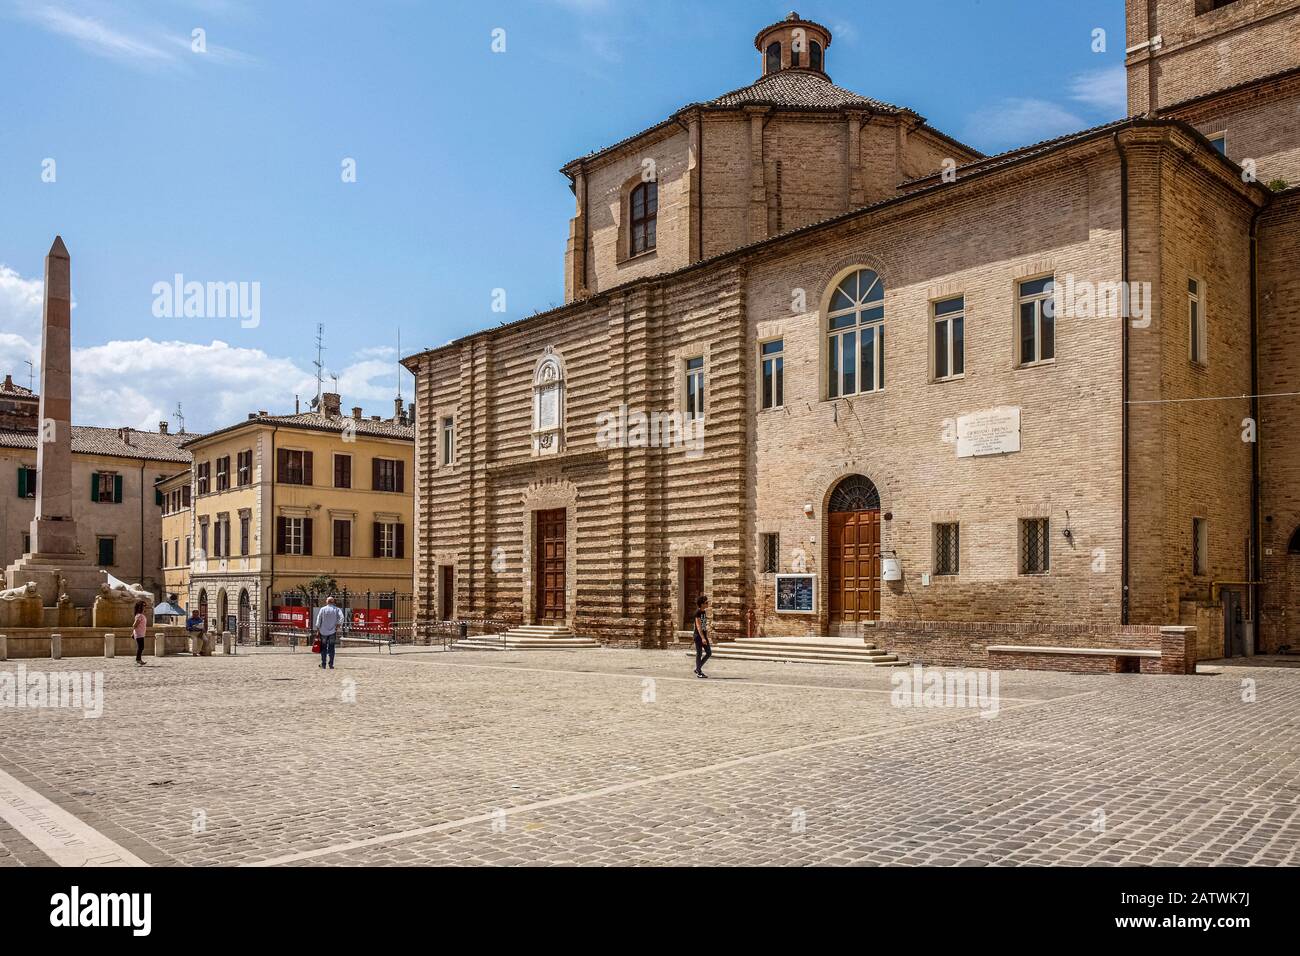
5,235,103,607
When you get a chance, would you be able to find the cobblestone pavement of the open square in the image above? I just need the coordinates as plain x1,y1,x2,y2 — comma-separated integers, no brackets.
0,650,1300,866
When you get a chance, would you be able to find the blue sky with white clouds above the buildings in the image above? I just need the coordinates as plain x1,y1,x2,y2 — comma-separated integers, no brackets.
0,0,1125,431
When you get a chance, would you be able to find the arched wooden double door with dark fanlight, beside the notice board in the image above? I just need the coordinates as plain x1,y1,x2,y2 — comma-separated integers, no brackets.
827,475,880,627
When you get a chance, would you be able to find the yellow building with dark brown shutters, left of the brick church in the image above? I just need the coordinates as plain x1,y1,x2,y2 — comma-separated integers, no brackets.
172,393,415,640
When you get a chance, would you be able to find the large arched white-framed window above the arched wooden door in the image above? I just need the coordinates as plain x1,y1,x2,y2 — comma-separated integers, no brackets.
826,269,885,398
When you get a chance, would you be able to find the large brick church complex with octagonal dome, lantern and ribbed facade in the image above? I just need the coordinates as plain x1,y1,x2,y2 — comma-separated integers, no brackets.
404,0,1300,662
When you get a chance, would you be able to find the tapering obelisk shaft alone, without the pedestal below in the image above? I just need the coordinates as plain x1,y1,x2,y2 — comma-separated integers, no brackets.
31,235,77,554
